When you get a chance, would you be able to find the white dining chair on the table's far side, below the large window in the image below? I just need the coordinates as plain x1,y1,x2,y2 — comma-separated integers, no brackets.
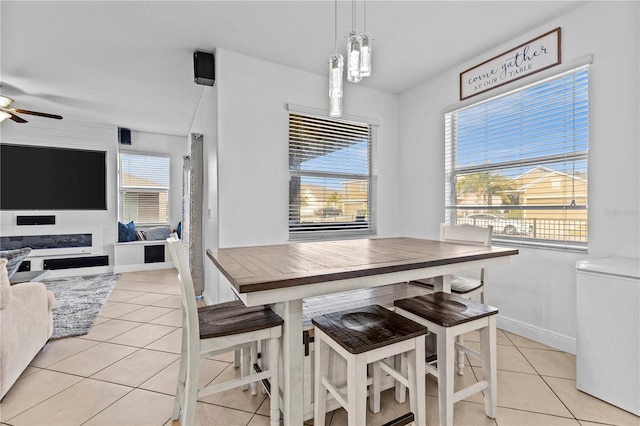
411,223,493,375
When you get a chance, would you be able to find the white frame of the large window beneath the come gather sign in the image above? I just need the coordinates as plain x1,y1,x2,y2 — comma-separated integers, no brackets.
444,62,590,252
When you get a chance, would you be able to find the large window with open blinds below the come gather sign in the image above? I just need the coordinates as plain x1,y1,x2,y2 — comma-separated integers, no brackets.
445,65,589,250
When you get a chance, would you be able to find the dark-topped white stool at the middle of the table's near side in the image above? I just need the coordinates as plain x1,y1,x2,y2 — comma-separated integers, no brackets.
312,305,428,426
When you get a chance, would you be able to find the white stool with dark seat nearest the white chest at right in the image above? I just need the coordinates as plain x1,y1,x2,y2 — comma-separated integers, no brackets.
394,292,498,426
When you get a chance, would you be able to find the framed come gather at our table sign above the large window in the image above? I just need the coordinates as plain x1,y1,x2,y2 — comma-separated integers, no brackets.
460,27,560,100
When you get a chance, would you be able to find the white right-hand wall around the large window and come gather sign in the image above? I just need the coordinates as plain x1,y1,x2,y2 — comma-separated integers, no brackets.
398,2,640,352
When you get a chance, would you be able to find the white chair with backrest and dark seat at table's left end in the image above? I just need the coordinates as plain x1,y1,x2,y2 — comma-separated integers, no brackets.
166,233,283,426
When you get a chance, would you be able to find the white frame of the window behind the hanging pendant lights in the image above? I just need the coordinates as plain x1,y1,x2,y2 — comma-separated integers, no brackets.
287,105,378,241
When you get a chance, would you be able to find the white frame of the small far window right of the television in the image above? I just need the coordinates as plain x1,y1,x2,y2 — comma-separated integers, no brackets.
118,150,171,227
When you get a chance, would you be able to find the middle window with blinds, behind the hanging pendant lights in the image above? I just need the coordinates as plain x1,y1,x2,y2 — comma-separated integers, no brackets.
289,112,375,239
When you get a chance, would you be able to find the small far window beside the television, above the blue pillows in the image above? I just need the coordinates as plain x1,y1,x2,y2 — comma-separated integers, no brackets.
118,152,169,225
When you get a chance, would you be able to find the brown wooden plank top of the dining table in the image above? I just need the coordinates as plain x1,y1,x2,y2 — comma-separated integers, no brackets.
207,237,518,293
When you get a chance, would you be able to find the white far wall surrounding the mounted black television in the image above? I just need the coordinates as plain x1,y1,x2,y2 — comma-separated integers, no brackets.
0,118,187,278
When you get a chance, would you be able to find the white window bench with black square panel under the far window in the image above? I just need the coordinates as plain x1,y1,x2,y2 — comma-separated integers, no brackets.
113,240,173,273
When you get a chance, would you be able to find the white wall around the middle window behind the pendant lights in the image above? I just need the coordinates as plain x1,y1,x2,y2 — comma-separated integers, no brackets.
199,48,398,301
